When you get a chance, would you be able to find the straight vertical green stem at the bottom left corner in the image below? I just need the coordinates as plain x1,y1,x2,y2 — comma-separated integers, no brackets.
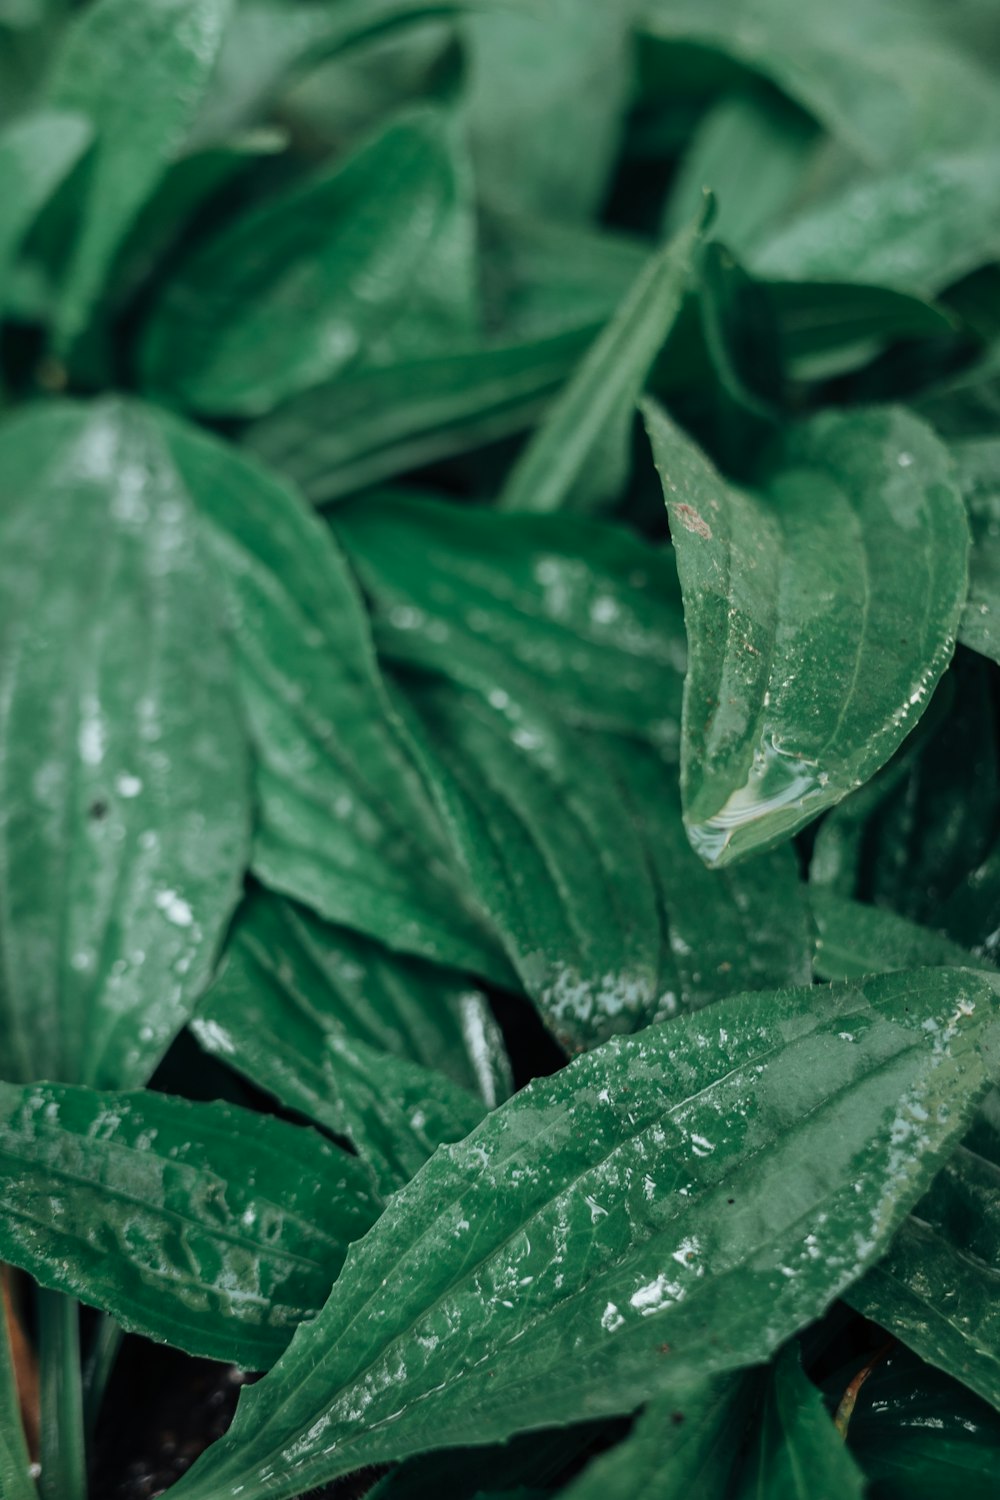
37,1287,87,1500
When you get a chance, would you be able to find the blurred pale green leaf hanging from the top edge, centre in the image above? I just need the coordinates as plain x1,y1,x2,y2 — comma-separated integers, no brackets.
462,0,631,221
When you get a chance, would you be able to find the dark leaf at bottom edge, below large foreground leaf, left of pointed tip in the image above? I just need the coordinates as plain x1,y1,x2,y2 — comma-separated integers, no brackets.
561,1376,757,1500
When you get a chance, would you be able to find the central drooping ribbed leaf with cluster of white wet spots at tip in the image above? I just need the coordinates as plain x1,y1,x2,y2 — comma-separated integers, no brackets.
396,674,660,1049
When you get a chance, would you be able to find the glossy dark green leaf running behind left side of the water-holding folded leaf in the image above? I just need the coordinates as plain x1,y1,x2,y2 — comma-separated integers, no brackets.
333,492,687,747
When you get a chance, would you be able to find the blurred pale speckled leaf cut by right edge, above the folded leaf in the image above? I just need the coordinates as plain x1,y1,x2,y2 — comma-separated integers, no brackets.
751,150,1000,297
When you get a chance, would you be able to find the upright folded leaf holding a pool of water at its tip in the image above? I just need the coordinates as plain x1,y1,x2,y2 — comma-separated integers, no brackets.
643,402,969,864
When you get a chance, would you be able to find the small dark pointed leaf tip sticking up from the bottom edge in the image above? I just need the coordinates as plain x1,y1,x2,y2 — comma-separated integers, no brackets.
736,1344,865,1500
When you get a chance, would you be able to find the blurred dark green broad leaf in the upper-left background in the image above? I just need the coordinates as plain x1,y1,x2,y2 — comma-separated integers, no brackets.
141,110,476,417
